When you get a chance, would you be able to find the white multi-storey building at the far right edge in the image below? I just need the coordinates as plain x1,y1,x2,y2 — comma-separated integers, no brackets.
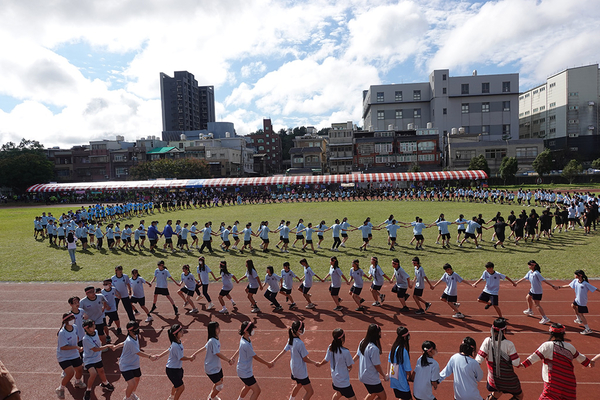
519,64,600,160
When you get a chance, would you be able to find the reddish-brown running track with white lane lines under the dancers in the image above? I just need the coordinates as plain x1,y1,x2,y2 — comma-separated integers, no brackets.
0,283,600,400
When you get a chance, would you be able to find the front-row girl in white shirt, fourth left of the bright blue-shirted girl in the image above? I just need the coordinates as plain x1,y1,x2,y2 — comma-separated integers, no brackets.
236,321,273,400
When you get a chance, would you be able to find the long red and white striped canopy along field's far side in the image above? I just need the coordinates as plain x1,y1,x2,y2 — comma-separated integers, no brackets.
27,170,488,193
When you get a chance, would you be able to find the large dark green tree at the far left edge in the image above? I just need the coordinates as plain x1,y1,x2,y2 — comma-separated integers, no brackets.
0,139,54,193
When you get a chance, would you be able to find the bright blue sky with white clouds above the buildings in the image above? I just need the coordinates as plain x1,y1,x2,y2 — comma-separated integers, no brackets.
0,0,600,147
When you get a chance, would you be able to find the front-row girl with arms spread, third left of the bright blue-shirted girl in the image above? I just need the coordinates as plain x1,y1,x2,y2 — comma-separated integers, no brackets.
271,321,317,400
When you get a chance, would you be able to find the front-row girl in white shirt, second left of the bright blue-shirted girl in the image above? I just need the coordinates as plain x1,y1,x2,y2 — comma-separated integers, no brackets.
316,328,356,400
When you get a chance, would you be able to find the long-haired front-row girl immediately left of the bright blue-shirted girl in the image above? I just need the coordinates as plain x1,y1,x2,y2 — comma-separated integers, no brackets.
353,324,388,400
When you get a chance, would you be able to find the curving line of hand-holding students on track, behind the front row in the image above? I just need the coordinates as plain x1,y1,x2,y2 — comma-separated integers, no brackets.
57,257,596,399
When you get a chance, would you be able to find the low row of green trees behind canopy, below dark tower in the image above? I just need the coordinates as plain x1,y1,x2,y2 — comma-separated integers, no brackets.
129,158,211,180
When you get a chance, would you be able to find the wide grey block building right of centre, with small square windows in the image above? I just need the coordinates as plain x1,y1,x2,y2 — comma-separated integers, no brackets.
363,69,519,140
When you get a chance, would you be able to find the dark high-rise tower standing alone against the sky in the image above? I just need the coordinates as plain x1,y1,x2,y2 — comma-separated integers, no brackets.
160,71,215,131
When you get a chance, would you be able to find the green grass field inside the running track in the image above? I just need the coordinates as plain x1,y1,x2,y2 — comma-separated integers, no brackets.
0,201,600,281
